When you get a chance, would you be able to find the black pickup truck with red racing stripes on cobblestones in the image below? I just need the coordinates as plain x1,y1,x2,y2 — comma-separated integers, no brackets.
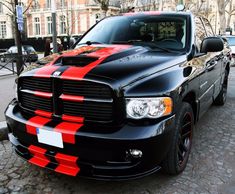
5,12,231,179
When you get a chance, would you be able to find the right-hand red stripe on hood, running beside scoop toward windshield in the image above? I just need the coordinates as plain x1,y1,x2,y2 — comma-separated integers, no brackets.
61,45,131,80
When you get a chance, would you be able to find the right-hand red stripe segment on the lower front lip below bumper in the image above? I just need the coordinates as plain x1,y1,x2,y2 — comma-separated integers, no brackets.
55,153,80,176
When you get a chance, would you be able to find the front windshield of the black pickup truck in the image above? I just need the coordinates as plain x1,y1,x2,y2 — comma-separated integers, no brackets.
76,15,186,50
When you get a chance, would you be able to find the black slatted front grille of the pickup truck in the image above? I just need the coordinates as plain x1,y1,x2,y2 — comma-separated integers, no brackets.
19,77,113,122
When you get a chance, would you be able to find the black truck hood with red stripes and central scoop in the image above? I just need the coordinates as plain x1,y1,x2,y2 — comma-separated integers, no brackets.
22,44,186,87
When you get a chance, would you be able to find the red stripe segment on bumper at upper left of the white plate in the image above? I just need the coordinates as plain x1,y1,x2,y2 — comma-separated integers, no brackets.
26,116,51,135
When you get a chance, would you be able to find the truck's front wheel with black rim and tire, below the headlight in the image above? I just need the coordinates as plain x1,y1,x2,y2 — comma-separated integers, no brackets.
162,102,194,175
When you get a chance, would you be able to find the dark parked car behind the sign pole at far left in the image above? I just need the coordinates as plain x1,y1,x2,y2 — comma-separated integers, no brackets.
0,45,38,62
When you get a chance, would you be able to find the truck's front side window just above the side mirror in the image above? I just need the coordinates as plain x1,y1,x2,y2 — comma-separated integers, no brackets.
194,17,207,51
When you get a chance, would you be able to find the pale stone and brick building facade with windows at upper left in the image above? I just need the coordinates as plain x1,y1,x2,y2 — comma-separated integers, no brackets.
0,0,120,39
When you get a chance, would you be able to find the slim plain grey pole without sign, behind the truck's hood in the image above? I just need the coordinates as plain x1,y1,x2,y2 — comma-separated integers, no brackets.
51,0,57,53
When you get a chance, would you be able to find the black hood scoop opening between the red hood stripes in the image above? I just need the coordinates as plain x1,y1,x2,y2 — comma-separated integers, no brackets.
61,56,99,67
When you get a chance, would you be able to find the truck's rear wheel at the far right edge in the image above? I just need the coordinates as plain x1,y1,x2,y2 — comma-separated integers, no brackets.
214,70,228,106
